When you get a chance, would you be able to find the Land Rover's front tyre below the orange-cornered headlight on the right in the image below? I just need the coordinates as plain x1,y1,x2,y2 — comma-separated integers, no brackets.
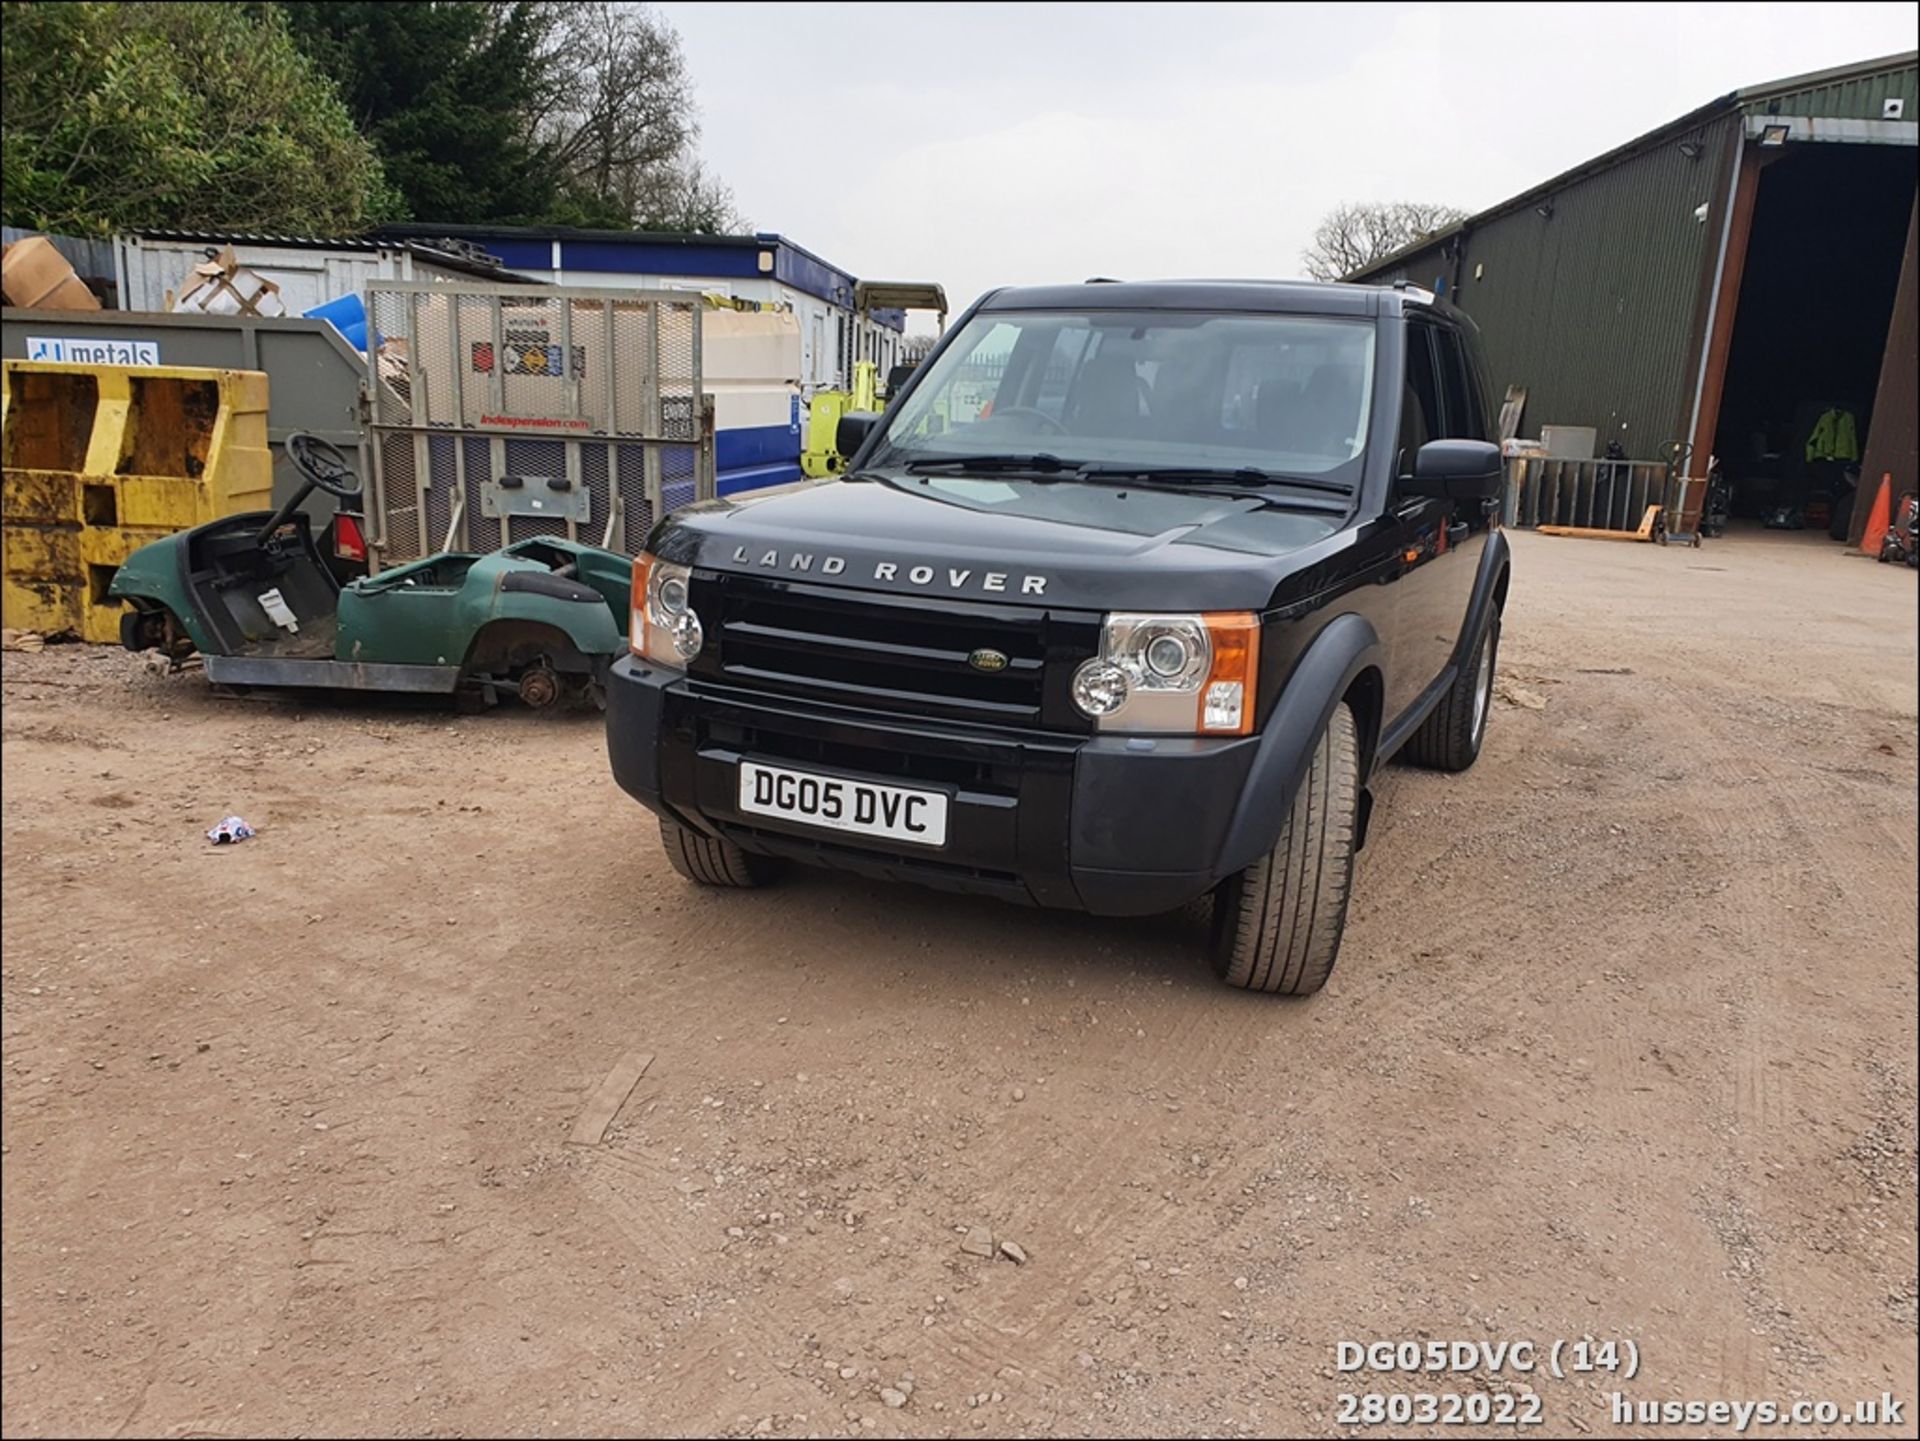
1210,706,1359,996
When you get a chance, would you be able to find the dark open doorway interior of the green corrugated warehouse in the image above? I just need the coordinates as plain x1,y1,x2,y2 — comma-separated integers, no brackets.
1715,144,1914,539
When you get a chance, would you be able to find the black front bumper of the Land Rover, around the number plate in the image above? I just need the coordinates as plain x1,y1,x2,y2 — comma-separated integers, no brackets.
607,656,1260,915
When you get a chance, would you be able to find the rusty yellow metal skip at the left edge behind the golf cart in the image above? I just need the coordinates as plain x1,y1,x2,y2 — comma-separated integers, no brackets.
0,361,273,643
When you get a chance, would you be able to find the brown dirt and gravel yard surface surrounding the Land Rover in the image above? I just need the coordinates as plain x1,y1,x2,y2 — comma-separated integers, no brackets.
4,533,1920,1437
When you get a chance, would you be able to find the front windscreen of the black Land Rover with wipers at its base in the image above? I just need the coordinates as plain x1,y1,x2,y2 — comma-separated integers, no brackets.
874,311,1373,482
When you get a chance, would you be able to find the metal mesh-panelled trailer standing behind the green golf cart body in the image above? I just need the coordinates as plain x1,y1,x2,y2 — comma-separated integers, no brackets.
367,282,714,570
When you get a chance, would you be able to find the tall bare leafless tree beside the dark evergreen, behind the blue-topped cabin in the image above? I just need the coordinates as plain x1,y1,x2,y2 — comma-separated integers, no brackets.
534,0,743,232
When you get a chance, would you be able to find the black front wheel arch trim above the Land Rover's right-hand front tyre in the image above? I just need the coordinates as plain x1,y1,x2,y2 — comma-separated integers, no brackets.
1217,612,1386,877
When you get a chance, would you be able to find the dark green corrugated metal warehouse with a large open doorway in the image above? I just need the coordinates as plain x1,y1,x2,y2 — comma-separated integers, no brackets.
1352,52,1920,539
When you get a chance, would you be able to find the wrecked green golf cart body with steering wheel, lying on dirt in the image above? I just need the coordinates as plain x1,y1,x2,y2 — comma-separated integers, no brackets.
109,437,634,706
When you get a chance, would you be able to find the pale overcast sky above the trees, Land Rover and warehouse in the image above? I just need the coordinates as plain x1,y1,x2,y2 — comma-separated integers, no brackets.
659,0,1920,328
